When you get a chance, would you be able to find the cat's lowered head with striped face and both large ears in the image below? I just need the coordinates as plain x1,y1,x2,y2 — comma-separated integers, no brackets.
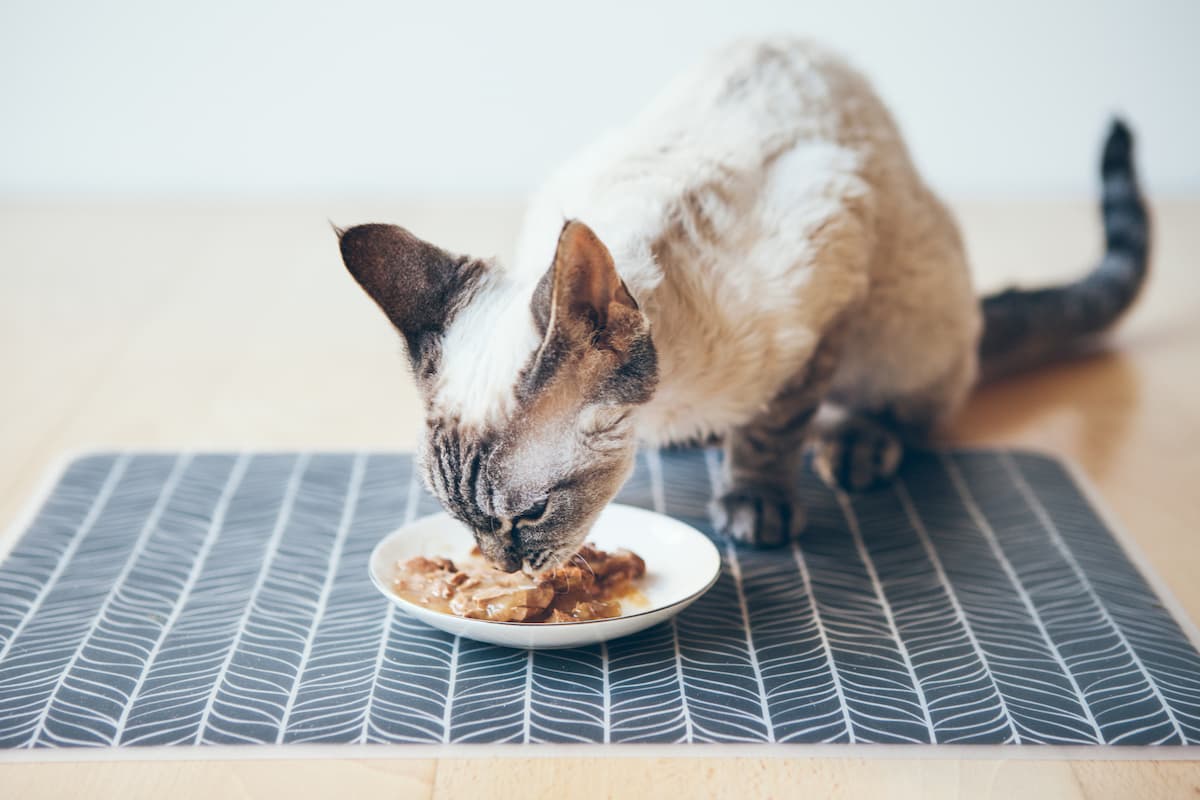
340,221,658,571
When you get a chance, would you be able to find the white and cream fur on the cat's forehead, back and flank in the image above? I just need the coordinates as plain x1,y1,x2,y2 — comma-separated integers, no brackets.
439,40,980,441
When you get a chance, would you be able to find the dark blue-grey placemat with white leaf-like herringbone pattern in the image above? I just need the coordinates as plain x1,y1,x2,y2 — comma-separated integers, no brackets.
0,450,1200,752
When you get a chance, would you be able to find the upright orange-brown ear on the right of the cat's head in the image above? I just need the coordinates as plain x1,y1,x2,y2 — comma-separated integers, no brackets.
533,219,644,350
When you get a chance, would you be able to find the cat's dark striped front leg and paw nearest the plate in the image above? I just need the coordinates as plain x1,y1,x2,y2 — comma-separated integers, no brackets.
712,335,841,547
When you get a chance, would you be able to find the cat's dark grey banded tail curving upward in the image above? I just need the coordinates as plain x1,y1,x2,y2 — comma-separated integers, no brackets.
979,120,1150,380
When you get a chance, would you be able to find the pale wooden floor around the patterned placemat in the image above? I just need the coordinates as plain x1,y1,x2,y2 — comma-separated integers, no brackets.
0,200,1200,800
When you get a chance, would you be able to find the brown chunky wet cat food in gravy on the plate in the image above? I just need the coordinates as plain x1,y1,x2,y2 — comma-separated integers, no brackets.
392,545,646,622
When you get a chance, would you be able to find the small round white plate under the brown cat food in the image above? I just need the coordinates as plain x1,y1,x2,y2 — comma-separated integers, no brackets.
370,504,721,649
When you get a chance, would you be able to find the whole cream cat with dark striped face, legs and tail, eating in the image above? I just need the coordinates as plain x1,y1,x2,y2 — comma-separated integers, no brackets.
337,38,1150,571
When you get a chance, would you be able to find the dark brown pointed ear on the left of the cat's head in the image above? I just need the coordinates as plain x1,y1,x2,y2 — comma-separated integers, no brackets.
334,224,484,367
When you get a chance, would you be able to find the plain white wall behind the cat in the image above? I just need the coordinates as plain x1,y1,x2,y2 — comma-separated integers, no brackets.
0,0,1200,197
